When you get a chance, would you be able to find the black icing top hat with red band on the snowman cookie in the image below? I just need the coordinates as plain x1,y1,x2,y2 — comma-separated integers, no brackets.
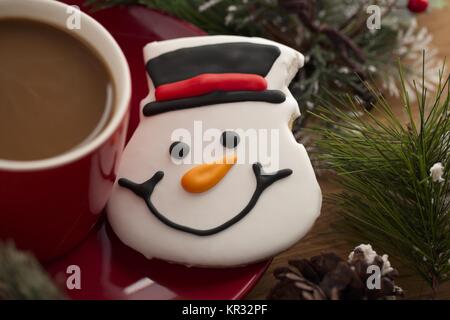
143,42,286,116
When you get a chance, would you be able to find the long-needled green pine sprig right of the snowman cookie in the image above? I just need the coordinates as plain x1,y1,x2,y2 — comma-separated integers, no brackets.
316,60,450,290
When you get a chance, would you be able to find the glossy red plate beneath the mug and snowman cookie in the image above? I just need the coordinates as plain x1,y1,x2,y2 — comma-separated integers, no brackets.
47,0,270,299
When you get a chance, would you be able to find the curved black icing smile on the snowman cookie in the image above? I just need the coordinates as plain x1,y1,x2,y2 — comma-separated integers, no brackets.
119,163,292,236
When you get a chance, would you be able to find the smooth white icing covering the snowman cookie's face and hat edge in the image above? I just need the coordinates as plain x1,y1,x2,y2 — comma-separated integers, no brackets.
107,36,322,267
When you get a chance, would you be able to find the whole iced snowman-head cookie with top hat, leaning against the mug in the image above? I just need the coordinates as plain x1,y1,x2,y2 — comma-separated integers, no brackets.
107,36,322,267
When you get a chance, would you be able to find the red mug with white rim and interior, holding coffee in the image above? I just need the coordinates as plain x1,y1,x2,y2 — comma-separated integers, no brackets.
0,0,131,261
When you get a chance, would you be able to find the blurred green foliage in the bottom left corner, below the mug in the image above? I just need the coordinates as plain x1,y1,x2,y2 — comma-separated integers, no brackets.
0,242,63,300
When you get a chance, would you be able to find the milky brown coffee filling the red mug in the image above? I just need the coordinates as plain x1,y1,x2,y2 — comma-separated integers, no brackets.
0,18,114,161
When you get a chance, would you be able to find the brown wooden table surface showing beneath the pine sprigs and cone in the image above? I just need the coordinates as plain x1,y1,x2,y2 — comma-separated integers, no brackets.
247,4,450,299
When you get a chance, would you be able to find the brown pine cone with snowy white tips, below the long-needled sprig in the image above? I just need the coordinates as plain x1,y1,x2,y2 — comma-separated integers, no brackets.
267,245,403,300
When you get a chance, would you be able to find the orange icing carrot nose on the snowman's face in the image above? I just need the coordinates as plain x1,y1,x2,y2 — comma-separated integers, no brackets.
181,155,237,193
